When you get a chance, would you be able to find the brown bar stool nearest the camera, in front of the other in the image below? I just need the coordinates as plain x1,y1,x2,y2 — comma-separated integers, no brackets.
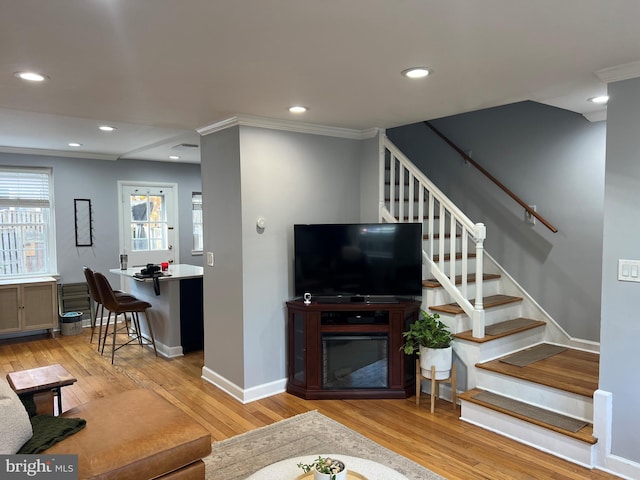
93,272,158,364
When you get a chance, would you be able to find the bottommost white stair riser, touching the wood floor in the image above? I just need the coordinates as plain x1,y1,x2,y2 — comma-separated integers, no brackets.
460,399,596,468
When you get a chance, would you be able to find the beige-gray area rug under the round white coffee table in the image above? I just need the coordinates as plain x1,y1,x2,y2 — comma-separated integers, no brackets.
204,411,444,480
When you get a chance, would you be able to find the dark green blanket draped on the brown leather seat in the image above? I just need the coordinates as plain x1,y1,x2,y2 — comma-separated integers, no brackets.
18,395,87,454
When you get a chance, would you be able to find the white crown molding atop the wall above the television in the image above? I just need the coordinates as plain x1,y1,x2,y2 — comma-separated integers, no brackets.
196,115,380,140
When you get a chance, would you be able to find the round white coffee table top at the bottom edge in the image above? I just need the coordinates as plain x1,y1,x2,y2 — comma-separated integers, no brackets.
246,453,407,480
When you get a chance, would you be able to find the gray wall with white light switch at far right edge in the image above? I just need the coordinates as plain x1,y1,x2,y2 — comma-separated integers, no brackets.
600,79,640,463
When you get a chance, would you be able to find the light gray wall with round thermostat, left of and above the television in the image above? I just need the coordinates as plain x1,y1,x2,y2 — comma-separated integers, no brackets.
201,126,362,390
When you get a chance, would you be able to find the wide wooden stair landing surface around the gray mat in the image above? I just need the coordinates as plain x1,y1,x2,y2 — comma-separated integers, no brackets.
476,348,600,398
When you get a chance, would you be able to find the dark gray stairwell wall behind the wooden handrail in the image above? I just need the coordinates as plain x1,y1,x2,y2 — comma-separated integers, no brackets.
387,102,606,341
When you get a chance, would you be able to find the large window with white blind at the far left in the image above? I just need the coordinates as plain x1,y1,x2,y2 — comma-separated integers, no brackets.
0,167,57,277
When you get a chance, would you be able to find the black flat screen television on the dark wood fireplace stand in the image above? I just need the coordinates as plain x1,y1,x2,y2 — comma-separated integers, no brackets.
294,223,422,301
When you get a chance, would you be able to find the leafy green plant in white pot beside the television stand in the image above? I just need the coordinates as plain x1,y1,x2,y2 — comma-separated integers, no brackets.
401,310,453,380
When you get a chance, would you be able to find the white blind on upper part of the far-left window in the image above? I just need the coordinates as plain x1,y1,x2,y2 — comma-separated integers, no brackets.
0,167,51,208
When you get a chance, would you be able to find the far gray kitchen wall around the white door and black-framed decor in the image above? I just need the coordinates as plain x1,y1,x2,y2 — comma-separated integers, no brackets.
0,153,202,283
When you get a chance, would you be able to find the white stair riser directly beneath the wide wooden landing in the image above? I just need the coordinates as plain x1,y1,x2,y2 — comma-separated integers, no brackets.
477,368,593,423
